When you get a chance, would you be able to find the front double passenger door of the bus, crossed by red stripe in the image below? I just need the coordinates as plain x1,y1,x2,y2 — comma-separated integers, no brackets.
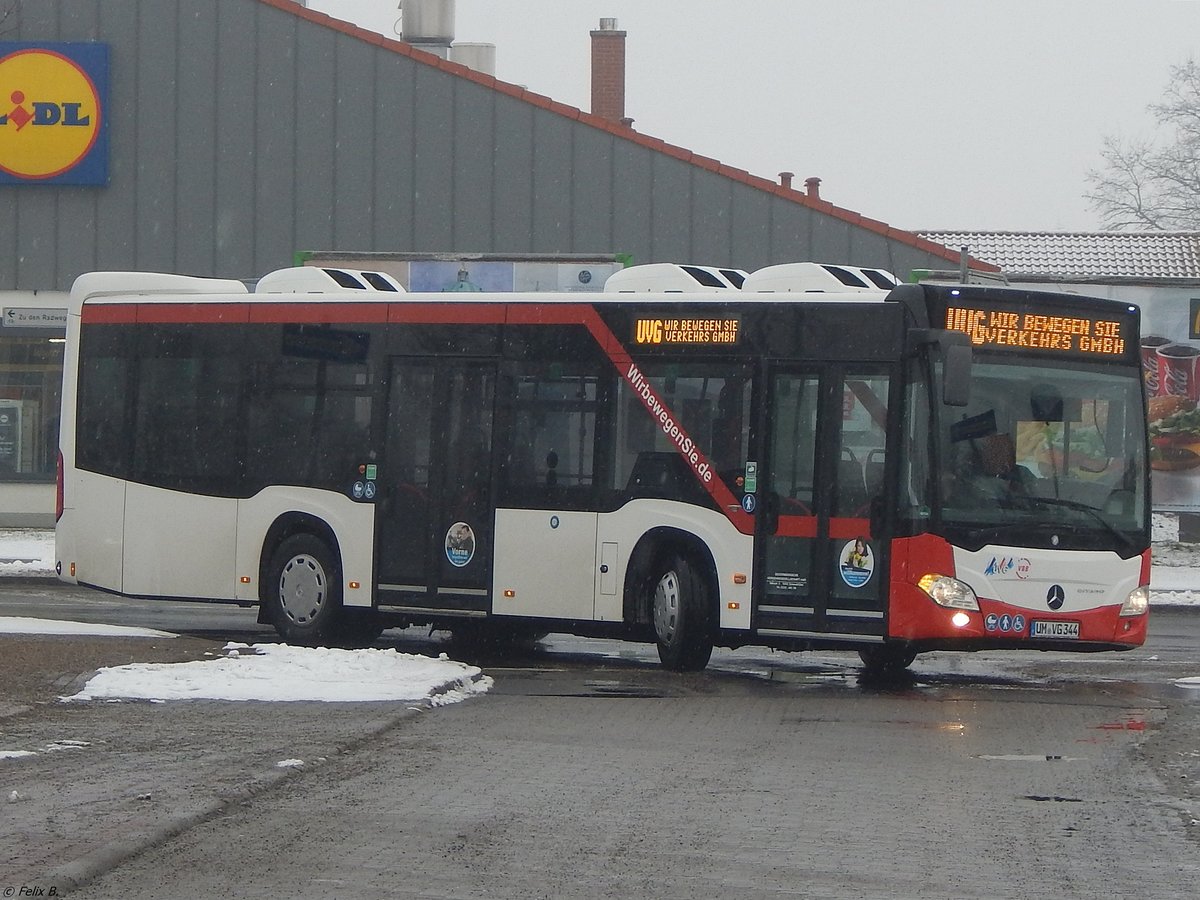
754,365,889,641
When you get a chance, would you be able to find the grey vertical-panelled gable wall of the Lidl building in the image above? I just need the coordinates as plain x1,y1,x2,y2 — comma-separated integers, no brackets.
0,0,948,289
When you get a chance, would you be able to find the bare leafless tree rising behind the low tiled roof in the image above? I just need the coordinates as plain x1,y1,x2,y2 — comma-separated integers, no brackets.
1084,59,1200,230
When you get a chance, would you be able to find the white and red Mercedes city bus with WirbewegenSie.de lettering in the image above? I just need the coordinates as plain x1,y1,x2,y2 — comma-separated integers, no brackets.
56,264,1150,670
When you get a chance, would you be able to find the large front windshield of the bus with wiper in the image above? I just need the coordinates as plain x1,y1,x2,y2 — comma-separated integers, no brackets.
932,355,1148,557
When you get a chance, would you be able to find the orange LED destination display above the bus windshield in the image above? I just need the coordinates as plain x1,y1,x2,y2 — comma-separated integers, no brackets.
946,306,1130,356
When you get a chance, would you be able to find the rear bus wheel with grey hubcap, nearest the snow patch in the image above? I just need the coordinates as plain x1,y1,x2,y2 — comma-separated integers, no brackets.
263,534,343,646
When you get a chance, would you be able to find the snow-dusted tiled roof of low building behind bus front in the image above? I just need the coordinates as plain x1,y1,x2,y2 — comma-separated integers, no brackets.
918,232,1200,278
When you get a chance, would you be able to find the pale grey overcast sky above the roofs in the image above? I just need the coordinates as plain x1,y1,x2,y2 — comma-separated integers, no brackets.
308,0,1200,230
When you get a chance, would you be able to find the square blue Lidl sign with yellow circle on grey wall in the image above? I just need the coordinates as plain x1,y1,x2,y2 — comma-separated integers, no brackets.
0,41,108,185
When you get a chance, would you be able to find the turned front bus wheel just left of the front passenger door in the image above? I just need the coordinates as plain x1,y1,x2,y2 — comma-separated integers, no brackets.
649,556,713,672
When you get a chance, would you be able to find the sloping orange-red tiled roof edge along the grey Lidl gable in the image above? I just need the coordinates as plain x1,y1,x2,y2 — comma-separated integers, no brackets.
258,0,992,271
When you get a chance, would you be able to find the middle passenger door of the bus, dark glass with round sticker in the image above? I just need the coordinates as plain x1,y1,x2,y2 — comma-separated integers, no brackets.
377,359,496,616
